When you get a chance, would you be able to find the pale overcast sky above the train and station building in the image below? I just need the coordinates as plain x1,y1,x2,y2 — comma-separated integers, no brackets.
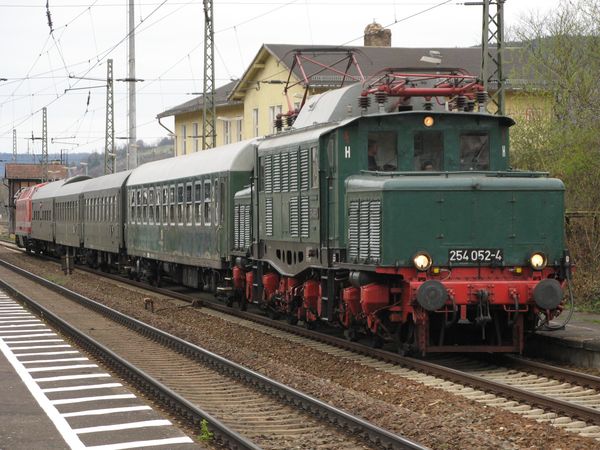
0,0,559,158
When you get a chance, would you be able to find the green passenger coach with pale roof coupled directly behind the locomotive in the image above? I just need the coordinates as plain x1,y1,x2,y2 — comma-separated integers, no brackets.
125,140,256,289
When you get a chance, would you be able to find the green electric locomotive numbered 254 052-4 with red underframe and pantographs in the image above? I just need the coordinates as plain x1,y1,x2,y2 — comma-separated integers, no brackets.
232,71,570,354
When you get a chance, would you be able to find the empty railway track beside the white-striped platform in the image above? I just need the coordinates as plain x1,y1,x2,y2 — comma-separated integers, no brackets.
0,256,424,449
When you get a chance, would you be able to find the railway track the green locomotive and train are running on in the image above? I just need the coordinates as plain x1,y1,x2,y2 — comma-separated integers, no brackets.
3,241,600,440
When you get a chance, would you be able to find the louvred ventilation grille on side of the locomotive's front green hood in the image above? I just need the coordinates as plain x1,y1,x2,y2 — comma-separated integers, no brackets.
348,200,381,263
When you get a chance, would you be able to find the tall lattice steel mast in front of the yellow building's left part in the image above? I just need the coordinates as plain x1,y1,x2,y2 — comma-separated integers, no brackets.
203,0,217,150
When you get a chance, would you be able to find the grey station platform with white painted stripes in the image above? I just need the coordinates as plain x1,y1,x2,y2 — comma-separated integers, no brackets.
0,292,200,450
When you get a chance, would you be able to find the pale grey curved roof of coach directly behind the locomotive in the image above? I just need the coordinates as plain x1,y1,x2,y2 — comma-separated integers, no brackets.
127,138,258,186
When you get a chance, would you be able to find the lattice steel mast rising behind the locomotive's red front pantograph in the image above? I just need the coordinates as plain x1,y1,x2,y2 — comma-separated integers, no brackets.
478,0,505,115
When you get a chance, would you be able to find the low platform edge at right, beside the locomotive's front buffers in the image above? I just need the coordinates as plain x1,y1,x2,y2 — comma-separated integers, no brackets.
525,311,600,368
